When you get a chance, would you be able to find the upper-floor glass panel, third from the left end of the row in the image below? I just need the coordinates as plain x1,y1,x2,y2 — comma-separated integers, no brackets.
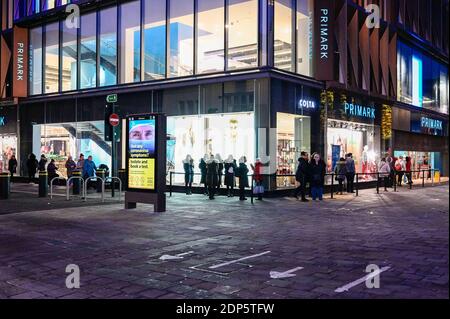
61,19,78,91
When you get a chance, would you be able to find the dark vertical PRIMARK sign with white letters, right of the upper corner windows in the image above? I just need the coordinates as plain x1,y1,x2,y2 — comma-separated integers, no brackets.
313,0,335,81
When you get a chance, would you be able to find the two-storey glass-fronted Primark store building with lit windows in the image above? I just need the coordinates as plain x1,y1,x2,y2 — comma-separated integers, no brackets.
0,0,449,187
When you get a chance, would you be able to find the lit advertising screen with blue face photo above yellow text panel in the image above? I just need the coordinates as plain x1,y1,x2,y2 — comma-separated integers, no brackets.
127,115,156,190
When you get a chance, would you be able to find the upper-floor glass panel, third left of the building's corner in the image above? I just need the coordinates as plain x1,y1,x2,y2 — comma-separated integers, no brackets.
167,0,194,77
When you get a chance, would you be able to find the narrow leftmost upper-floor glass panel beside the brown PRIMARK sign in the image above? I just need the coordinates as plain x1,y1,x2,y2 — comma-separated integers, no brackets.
29,27,42,95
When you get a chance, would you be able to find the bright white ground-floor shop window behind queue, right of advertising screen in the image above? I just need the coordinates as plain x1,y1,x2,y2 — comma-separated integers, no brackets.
167,112,255,183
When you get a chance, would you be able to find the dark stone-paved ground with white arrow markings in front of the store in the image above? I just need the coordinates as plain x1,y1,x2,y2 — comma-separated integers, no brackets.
0,185,449,299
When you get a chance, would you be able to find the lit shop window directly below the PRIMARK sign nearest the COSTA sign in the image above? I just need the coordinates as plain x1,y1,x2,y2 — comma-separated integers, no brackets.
327,120,380,180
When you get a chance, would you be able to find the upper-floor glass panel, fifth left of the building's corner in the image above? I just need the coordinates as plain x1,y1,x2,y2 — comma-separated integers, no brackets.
120,1,141,83
